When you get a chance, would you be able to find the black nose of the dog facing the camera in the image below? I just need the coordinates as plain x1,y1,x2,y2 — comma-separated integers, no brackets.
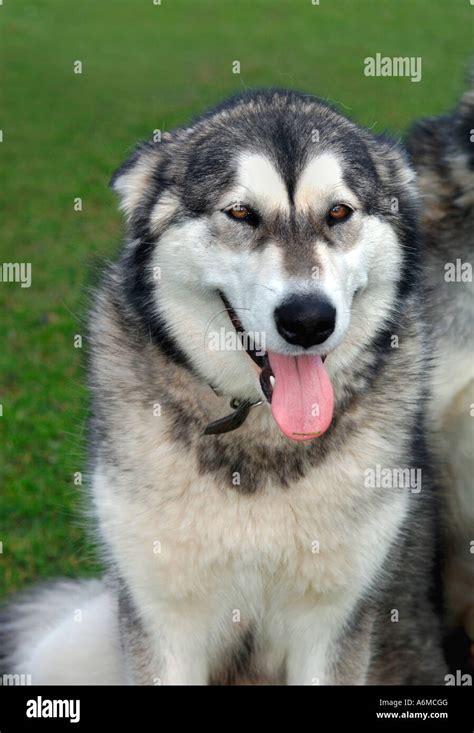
274,295,336,349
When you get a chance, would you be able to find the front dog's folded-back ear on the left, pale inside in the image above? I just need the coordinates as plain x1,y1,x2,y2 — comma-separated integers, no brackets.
110,142,166,221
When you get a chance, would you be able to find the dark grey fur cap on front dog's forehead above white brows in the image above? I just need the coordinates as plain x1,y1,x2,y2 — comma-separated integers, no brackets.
184,92,377,211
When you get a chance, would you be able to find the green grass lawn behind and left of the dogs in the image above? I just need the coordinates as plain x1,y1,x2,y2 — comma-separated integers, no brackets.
0,0,474,595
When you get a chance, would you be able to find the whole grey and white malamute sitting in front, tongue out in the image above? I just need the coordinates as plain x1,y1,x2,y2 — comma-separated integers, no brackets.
4,91,446,685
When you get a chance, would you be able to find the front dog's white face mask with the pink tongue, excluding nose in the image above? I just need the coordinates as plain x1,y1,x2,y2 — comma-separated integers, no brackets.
116,146,401,440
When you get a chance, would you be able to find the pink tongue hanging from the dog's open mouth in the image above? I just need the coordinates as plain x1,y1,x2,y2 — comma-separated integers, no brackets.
268,351,334,440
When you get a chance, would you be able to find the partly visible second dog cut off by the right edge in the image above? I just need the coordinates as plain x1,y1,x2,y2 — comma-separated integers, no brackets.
408,74,474,657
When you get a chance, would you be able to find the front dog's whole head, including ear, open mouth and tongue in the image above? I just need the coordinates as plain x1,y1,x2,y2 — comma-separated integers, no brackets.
112,92,416,439
